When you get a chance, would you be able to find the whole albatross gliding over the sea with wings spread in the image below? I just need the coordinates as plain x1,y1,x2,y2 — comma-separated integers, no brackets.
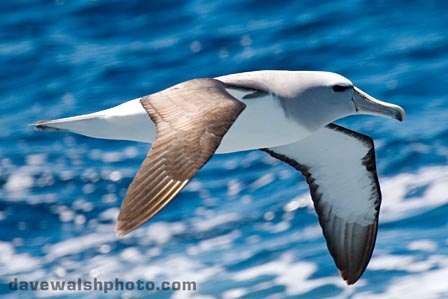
33,70,405,284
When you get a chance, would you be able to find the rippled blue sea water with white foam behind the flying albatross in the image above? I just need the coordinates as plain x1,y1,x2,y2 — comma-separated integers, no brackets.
0,0,448,299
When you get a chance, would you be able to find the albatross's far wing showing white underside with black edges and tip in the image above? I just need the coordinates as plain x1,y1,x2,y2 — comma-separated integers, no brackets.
263,124,381,284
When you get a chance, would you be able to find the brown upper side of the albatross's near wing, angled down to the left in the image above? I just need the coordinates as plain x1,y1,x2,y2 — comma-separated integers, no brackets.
116,79,245,236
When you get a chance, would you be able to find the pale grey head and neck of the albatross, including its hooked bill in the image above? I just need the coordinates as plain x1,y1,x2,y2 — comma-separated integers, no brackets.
217,71,405,131
